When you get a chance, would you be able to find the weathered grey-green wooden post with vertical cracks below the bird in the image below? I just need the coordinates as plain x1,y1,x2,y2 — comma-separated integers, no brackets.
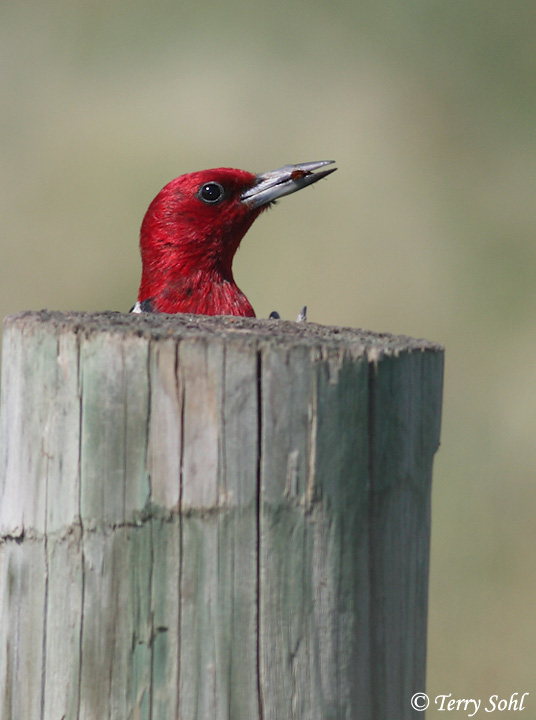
0,312,443,720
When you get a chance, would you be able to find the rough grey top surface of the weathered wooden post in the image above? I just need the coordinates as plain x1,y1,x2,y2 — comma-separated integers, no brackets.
4,310,443,360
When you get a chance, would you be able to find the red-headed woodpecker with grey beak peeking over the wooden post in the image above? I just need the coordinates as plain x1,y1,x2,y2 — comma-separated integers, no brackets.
132,160,337,319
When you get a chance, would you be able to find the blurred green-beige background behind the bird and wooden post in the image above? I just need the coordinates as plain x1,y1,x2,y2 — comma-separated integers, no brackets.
0,0,536,718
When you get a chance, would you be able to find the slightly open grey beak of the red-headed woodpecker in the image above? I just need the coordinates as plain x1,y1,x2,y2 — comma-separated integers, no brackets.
240,160,337,208
